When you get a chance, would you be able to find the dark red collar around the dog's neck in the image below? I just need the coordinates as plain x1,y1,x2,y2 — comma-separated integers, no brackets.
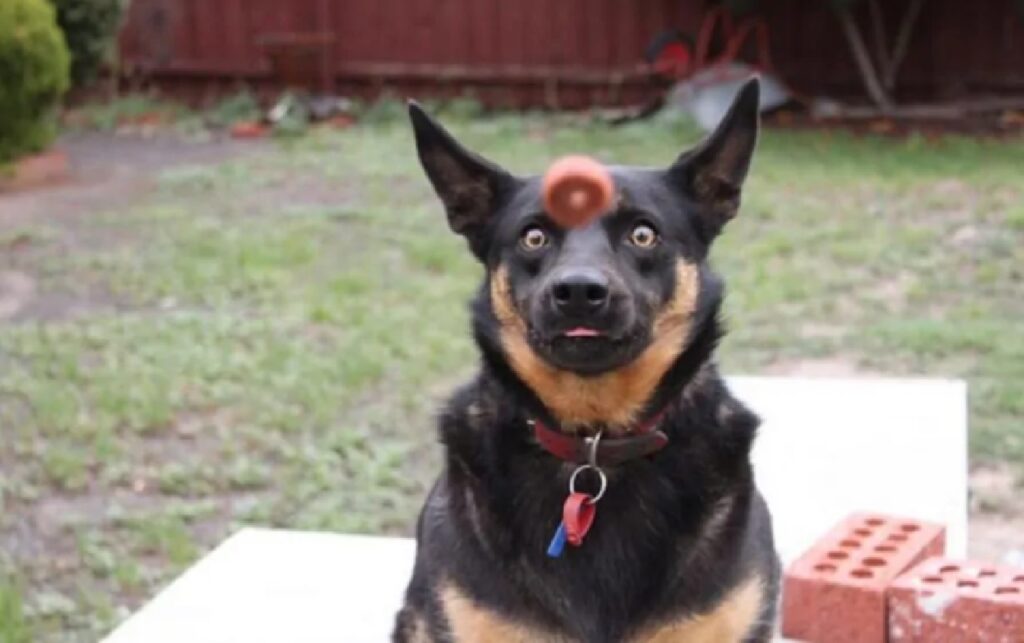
532,411,669,466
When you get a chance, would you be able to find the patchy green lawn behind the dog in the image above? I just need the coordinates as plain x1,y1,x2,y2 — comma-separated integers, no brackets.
0,105,1024,643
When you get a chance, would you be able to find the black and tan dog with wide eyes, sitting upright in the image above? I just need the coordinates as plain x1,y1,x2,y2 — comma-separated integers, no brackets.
394,80,778,643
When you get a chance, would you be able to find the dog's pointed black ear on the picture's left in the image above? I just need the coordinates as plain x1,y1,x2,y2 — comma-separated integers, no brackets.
409,100,507,253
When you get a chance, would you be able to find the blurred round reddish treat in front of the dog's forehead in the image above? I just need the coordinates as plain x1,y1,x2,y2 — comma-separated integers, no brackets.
543,156,615,228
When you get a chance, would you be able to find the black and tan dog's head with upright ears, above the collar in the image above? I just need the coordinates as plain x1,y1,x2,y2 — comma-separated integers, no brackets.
410,80,759,432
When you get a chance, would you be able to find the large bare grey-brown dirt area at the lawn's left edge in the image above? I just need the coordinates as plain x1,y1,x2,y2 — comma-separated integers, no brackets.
0,133,268,323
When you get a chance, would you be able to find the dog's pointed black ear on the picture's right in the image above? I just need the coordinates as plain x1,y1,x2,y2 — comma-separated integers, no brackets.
669,78,761,241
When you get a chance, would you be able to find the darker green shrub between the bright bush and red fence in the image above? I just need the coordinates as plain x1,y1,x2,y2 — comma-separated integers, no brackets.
50,0,126,87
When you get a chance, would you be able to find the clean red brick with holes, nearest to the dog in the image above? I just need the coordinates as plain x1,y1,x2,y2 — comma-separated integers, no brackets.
782,514,945,643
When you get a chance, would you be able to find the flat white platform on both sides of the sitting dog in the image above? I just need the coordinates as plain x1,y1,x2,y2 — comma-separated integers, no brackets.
105,378,967,643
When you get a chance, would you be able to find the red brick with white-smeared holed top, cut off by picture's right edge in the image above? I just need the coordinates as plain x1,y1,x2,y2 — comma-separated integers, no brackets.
888,558,1024,643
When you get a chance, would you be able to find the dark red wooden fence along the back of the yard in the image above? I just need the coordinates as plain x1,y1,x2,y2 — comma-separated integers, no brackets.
121,0,1024,108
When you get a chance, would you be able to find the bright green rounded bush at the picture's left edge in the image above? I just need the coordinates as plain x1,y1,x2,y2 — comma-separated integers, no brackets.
0,0,69,163
